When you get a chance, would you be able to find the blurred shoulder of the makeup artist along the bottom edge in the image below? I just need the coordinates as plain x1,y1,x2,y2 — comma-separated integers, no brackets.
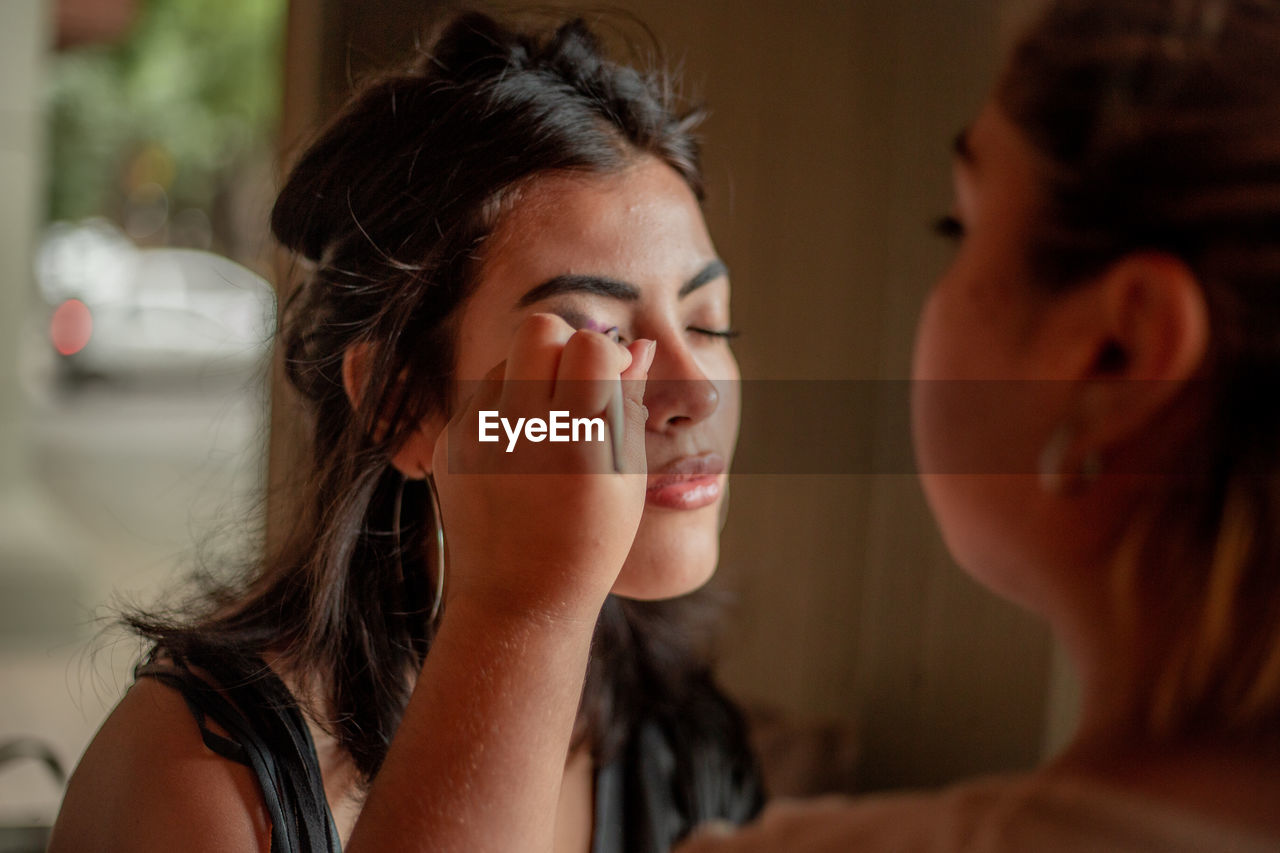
680,775,1280,853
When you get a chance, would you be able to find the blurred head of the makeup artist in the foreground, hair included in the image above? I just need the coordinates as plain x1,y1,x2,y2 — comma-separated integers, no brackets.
916,0,1280,736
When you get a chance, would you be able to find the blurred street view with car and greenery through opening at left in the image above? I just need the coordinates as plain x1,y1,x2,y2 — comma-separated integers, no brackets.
0,0,285,835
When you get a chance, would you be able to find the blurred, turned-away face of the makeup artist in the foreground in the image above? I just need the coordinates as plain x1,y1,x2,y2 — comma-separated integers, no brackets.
913,99,1071,610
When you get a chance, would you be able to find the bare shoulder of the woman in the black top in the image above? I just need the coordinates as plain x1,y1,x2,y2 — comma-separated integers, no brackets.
49,678,270,853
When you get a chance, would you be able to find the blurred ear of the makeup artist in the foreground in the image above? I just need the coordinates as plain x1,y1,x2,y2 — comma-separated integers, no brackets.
1080,252,1210,448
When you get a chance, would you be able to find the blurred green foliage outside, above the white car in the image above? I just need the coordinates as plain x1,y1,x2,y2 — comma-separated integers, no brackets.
46,0,287,220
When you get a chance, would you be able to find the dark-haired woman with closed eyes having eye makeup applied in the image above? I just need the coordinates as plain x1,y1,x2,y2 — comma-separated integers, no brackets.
50,14,760,853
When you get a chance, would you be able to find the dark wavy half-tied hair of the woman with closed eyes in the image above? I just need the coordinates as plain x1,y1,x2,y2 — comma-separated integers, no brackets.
128,13,758,814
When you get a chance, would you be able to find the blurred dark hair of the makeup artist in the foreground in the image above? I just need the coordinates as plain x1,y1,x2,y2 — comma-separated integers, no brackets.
996,0,1280,738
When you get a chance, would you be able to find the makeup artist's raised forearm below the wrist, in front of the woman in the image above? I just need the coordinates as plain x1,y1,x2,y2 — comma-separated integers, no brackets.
346,591,594,853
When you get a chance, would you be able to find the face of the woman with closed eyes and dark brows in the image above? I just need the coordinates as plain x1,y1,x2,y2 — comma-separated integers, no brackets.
454,156,740,599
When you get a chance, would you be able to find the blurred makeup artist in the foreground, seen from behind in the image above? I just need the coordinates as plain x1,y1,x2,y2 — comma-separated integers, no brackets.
317,0,1280,853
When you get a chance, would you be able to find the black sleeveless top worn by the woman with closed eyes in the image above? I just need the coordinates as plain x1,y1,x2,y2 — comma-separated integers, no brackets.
134,649,763,853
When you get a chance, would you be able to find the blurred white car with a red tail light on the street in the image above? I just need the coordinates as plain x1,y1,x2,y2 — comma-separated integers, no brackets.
36,220,275,378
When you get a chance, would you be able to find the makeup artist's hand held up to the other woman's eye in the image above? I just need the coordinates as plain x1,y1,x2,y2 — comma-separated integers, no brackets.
433,308,655,622
